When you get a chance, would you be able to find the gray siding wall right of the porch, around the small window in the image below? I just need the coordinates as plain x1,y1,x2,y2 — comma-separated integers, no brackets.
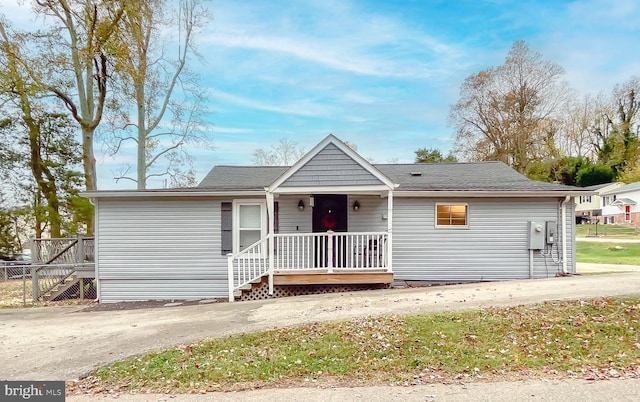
393,198,575,282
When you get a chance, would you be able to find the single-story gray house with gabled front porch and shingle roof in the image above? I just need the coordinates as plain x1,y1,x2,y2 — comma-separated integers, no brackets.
85,135,593,302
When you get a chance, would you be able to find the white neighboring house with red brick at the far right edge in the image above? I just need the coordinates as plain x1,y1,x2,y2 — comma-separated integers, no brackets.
601,182,640,227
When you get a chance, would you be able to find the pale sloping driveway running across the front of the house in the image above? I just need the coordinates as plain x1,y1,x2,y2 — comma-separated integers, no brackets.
0,272,640,380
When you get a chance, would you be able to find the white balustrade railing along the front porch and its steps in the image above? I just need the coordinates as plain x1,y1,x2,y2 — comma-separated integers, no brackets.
228,231,391,301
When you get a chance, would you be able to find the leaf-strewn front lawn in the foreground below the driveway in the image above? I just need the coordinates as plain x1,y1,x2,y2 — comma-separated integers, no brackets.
75,297,640,393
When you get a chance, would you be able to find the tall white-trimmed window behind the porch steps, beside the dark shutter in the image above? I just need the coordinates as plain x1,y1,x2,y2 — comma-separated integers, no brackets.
233,201,267,253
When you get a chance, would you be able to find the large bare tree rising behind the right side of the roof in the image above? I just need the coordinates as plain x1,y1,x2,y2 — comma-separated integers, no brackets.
449,41,568,173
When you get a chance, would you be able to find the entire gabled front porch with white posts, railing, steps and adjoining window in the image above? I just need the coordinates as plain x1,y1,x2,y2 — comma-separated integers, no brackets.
223,135,398,301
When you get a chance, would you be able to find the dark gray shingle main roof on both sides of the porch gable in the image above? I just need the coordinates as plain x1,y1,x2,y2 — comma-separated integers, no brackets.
198,162,584,191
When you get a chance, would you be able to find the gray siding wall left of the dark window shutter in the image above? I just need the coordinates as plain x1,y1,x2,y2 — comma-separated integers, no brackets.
96,198,228,303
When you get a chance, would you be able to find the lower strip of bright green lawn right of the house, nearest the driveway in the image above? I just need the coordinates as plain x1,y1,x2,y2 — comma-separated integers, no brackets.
576,241,640,265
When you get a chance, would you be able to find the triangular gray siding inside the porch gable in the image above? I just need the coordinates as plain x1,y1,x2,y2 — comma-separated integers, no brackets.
281,144,382,187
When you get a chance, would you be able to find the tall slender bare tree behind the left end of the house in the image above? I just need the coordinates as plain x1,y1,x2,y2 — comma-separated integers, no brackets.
112,0,210,189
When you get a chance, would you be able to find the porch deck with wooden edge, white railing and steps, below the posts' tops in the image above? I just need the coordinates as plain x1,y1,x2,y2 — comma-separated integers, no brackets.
228,231,393,301
